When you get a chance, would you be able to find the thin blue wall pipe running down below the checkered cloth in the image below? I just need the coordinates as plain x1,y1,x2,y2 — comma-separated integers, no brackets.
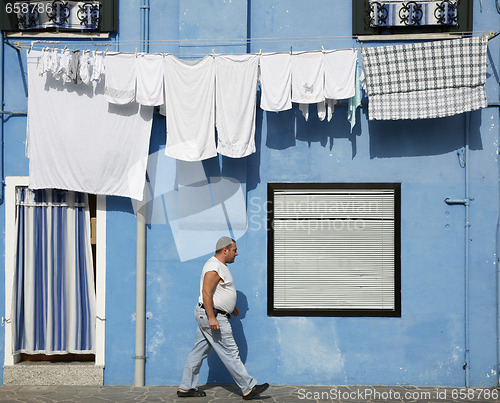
445,112,474,388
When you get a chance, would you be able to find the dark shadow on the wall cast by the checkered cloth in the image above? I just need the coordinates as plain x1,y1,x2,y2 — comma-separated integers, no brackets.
368,111,483,158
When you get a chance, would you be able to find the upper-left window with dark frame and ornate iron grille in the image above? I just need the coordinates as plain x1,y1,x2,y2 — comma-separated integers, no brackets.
0,0,118,35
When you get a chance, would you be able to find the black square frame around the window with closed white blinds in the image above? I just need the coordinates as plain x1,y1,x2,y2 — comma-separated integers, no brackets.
267,182,401,317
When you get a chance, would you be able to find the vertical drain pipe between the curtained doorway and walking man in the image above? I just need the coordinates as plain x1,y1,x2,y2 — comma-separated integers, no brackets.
134,0,149,386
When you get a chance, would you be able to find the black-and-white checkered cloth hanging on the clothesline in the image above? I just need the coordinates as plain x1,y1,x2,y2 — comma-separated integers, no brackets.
363,37,487,120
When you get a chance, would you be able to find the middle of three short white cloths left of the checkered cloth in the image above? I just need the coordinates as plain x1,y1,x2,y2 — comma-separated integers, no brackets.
292,52,325,104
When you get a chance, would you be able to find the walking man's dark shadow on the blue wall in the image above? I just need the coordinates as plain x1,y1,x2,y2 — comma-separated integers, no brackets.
207,291,251,384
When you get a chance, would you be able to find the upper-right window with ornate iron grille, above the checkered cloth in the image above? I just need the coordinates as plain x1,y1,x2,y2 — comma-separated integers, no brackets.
353,0,473,39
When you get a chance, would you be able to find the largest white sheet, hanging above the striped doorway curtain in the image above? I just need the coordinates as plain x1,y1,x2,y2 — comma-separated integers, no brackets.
27,50,153,200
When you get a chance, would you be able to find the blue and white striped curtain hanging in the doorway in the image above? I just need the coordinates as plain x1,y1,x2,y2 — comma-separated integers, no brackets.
11,187,95,355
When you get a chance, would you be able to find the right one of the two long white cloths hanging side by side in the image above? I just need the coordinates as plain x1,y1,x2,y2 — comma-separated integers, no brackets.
215,55,259,158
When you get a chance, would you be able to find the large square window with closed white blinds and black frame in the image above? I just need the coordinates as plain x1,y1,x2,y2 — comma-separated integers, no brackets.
268,183,401,316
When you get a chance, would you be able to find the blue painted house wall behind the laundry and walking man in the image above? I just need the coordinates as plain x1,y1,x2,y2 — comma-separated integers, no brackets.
0,0,500,386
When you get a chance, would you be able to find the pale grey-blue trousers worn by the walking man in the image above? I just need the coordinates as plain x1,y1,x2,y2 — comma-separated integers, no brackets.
179,306,257,394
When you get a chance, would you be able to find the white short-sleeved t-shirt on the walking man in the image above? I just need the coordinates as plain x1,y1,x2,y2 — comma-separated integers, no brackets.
198,256,236,313
